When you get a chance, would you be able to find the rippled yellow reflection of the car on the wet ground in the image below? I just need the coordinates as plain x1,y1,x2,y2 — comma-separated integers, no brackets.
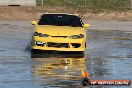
32,54,85,80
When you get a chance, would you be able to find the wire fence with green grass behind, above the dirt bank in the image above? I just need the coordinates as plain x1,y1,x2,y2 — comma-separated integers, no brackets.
37,0,132,9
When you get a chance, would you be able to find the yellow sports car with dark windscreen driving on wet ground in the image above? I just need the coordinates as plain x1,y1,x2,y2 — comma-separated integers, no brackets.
31,13,89,52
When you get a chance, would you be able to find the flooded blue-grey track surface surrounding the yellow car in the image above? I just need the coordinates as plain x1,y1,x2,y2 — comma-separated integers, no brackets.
0,24,132,88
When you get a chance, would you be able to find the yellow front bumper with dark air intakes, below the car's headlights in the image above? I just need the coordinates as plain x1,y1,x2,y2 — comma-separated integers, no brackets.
32,37,85,51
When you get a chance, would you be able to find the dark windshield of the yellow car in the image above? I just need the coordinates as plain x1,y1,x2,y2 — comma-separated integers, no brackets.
38,14,82,27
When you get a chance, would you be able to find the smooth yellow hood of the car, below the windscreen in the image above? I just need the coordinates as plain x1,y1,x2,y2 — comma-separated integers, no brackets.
36,25,85,36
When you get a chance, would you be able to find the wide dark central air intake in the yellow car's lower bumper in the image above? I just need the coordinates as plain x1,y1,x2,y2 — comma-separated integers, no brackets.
47,42,69,48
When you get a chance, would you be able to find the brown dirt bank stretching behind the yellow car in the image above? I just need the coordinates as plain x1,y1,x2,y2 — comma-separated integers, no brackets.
0,6,132,21
